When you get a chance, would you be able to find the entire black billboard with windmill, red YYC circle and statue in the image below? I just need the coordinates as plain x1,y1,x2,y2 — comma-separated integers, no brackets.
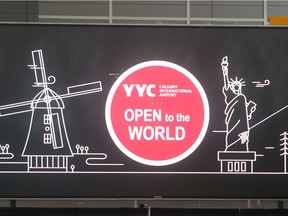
0,24,288,198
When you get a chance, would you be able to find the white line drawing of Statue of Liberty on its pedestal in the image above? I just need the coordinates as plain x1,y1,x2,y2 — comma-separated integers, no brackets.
218,56,256,173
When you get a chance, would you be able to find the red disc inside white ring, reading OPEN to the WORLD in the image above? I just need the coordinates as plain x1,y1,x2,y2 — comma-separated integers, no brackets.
106,60,208,164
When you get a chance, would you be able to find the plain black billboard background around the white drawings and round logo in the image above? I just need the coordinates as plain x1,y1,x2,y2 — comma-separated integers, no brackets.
0,24,288,198
